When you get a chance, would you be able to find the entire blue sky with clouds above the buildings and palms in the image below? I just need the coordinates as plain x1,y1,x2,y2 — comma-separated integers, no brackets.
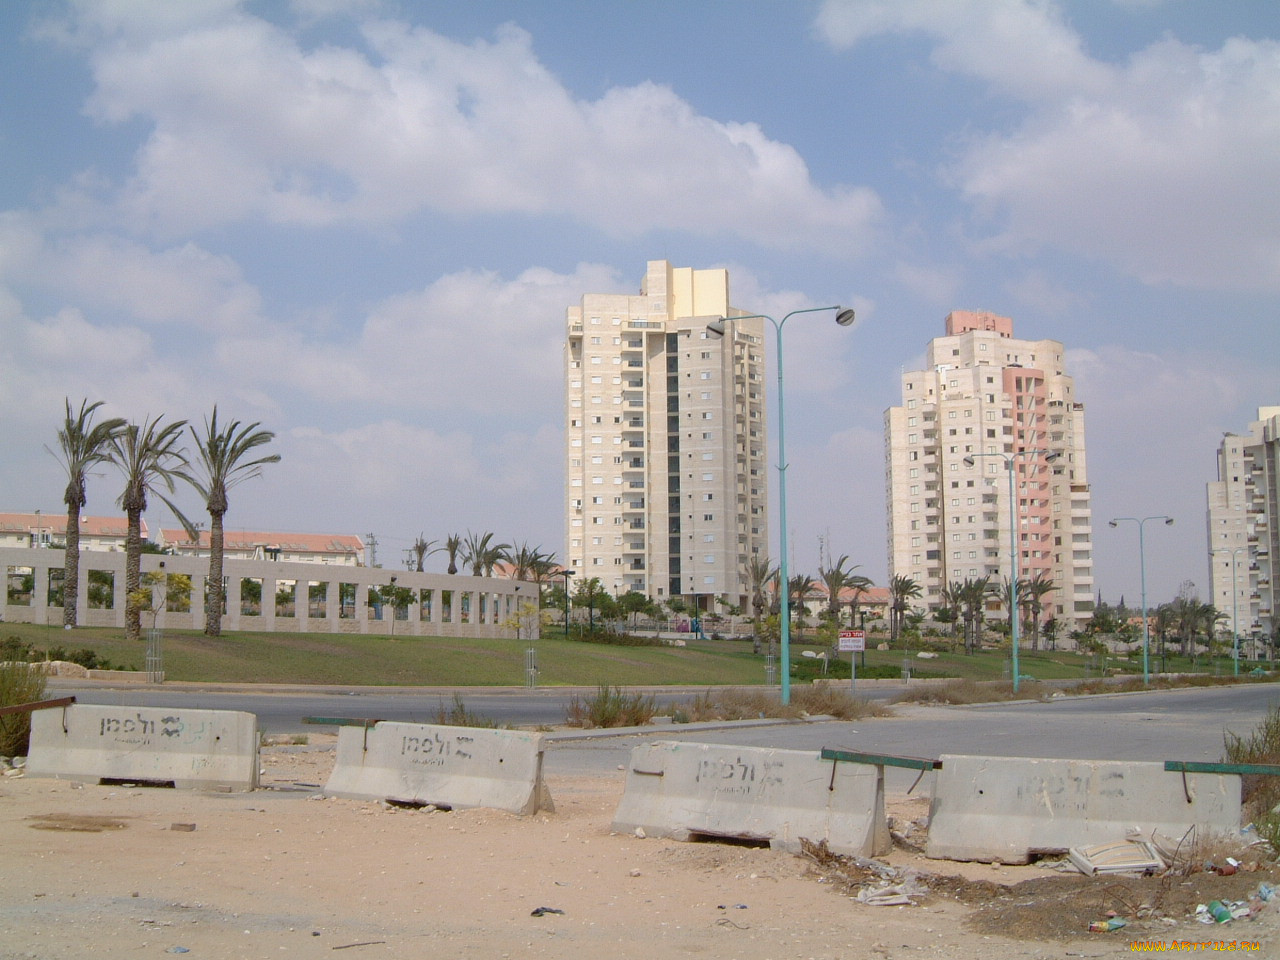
0,0,1280,603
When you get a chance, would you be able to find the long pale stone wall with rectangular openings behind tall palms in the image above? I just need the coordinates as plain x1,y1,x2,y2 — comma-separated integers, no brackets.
0,547,539,639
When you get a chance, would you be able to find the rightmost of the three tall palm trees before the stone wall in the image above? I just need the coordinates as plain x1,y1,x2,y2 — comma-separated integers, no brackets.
187,404,280,636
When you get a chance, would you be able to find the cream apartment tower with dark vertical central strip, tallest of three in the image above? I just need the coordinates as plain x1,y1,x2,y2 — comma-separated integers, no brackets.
564,260,768,609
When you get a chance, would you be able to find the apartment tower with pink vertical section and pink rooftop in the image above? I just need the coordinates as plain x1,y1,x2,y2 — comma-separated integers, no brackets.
884,310,1094,636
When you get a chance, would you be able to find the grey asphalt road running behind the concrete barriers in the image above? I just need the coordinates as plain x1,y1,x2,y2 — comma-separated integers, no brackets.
50,681,1280,790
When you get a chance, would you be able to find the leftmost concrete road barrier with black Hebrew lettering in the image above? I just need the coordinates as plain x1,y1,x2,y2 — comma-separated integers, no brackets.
27,704,259,790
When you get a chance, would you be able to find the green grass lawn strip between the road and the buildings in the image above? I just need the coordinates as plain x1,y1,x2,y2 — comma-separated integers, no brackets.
0,623,1253,687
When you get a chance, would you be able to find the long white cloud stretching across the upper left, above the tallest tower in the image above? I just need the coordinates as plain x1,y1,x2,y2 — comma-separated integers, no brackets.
55,10,882,256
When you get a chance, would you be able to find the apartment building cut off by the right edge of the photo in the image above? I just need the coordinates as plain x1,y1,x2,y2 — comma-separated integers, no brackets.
1208,407,1280,657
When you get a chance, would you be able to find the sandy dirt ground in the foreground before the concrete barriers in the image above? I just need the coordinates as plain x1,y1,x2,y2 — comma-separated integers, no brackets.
0,735,1280,960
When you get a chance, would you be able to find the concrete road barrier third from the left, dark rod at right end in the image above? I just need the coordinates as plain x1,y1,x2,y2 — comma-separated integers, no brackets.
613,741,890,856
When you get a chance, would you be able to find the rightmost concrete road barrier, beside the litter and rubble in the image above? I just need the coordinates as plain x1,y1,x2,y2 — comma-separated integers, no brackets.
925,755,1240,864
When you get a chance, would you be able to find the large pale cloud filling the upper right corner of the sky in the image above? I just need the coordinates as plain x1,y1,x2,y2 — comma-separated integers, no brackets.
818,0,1280,291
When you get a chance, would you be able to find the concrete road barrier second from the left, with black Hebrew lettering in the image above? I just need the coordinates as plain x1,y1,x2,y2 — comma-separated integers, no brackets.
324,722,554,814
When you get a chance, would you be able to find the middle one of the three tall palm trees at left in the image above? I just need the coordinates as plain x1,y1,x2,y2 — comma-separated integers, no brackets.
110,417,192,640
